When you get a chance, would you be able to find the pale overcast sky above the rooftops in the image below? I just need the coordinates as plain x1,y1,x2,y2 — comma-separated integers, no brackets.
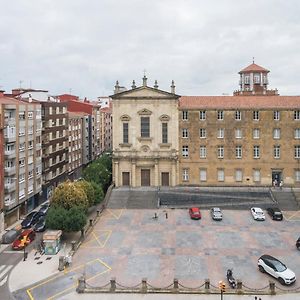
0,0,300,98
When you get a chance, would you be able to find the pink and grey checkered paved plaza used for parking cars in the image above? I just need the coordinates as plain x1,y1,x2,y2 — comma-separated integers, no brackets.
11,209,300,299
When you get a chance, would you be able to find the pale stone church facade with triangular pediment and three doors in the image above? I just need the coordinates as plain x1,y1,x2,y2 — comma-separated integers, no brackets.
111,76,179,187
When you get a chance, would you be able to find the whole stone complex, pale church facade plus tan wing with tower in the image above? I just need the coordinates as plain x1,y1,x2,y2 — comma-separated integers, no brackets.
111,62,300,187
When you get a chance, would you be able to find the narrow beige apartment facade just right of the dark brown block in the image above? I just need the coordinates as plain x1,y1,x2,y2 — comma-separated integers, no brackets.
68,112,85,180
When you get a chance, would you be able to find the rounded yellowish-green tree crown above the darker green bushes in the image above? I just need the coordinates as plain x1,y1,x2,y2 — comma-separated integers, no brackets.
51,180,88,211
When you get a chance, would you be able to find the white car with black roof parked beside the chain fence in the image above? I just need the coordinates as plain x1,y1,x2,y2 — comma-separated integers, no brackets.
257,254,296,284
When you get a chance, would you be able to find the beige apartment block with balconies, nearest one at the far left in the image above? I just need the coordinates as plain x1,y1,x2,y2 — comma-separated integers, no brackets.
0,92,42,227
